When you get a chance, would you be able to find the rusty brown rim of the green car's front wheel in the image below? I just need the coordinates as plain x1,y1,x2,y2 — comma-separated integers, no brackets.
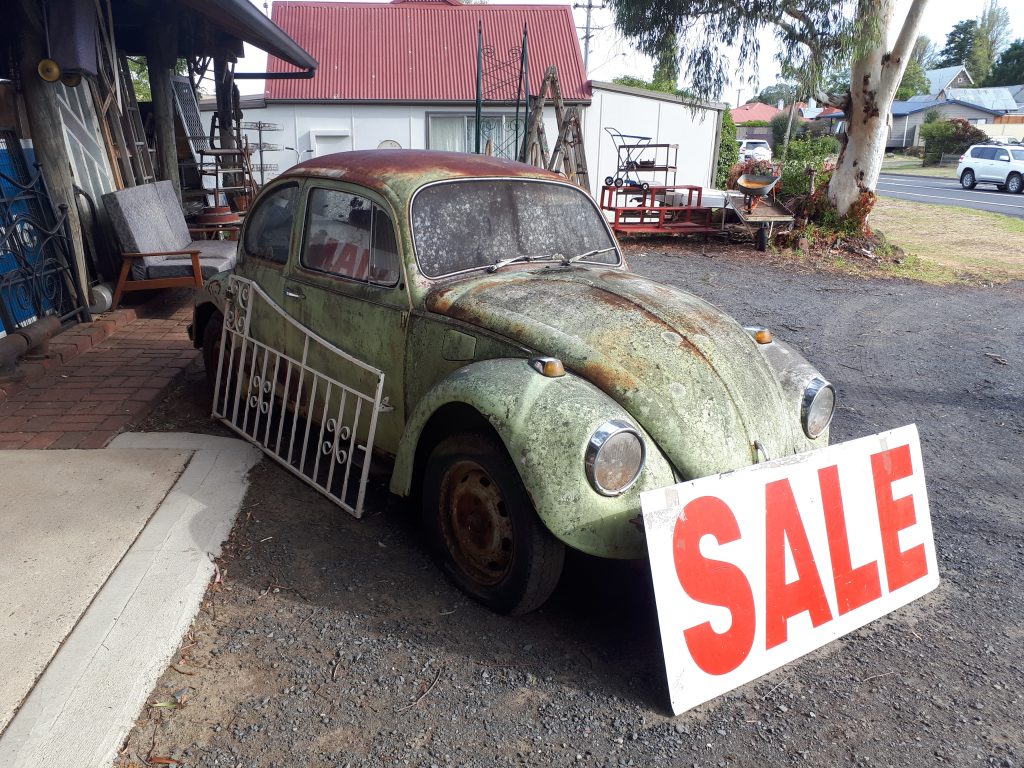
438,461,513,587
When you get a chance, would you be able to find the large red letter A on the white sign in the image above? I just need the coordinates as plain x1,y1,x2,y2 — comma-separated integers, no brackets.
765,480,831,648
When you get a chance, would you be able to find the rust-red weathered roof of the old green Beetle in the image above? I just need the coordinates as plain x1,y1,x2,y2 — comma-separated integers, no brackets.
282,150,564,198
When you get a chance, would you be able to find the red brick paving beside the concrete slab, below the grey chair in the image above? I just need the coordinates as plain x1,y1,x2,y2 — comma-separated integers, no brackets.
0,295,199,449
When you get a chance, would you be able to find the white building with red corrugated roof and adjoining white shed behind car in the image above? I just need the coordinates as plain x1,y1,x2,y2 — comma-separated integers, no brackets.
227,0,725,190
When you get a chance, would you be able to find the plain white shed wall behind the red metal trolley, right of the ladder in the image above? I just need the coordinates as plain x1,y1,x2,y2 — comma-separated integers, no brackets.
584,82,721,195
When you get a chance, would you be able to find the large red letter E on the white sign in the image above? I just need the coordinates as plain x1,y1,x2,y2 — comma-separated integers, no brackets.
871,445,928,592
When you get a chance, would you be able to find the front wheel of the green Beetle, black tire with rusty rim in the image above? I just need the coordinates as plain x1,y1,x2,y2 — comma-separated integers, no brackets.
422,433,565,614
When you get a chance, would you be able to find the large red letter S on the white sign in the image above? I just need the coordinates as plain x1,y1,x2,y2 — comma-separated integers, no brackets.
672,496,757,675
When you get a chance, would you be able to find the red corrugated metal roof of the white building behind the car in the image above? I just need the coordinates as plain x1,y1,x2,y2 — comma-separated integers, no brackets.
266,0,590,103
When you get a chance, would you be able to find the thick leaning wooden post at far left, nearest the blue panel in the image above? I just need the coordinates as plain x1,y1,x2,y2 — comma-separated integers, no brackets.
18,0,92,303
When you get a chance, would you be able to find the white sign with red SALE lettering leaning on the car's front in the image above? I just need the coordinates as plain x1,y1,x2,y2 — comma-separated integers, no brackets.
641,425,939,715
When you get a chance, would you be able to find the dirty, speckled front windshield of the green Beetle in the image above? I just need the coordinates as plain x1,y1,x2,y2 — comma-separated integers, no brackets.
413,179,620,278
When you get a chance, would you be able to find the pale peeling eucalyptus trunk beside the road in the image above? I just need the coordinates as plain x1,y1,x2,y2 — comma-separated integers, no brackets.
828,0,927,216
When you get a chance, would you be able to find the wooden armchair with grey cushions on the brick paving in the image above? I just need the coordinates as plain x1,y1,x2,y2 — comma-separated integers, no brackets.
103,181,239,309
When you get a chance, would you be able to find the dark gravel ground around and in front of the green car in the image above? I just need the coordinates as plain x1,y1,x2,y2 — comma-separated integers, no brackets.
122,244,1024,768
